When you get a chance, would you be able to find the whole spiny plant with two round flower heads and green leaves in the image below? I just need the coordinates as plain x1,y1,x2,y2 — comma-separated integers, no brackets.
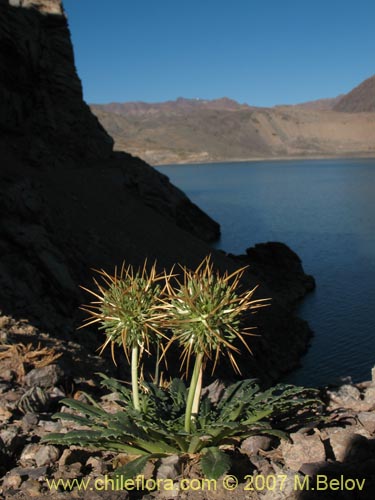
44,257,319,478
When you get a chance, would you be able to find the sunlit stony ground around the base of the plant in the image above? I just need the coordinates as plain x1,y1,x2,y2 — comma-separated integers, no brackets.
0,316,375,500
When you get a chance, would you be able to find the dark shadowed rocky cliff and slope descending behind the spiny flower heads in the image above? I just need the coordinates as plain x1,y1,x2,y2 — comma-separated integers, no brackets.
0,0,309,379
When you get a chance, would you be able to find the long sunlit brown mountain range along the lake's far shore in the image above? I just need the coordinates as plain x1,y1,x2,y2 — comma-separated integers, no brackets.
91,79,375,165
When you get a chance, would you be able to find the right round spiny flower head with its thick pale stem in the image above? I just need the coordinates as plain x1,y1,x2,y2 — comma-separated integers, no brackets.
163,256,269,432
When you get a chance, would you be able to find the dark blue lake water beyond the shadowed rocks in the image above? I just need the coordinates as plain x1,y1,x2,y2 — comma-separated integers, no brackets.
158,159,375,385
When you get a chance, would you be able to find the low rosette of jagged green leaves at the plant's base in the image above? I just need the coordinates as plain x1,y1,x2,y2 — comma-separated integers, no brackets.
44,374,318,479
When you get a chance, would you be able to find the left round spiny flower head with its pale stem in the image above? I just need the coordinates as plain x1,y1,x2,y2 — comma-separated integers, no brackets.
81,260,173,411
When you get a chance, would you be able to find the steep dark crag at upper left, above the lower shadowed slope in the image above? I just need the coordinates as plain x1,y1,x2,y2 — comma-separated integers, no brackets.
0,0,113,168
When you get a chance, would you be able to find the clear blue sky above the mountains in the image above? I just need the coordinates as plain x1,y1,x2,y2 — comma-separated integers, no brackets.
63,0,375,106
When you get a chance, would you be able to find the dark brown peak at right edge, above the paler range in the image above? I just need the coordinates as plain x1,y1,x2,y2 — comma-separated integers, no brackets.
333,75,375,113
